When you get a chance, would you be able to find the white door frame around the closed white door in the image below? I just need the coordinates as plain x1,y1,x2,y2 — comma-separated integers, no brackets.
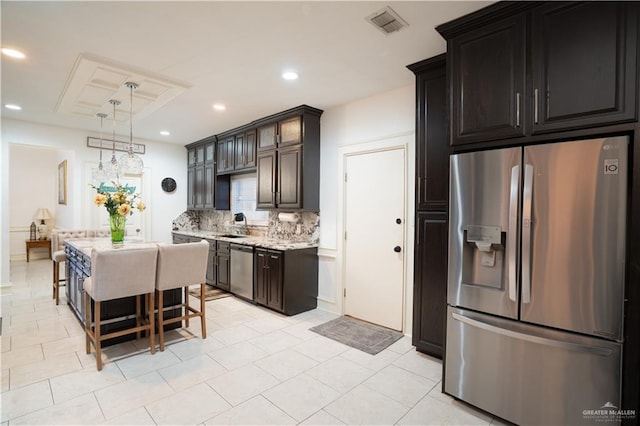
336,132,415,335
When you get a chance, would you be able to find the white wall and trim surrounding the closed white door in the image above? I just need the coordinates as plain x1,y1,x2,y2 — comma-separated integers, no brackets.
318,85,415,334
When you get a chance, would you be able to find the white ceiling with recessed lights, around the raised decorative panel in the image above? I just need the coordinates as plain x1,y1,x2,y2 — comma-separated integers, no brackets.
0,1,491,145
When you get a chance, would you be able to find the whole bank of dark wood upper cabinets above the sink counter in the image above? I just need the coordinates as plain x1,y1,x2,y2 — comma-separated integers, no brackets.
186,105,322,211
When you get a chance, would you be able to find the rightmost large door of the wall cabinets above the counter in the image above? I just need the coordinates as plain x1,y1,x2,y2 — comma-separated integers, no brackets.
276,145,302,208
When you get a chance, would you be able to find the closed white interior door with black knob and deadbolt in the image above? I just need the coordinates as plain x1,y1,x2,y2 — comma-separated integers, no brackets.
343,148,405,331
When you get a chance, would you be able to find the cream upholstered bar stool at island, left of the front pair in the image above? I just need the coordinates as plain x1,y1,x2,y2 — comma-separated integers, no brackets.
84,246,158,371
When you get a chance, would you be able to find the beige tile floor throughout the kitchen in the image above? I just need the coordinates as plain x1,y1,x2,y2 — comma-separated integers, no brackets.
0,260,498,426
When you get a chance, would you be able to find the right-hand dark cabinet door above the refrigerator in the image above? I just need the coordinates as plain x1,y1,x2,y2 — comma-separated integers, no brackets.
531,2,638,133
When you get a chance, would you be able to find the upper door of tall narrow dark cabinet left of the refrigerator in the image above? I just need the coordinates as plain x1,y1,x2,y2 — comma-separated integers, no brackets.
416,60,449,210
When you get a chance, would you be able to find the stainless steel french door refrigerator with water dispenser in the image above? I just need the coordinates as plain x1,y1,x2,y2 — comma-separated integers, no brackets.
444,136,629,425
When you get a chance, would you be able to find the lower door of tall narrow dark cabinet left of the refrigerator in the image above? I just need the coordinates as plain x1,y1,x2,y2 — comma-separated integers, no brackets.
412,212,448,358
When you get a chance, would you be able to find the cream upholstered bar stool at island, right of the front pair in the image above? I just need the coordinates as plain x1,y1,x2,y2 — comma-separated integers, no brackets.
156,240,209,351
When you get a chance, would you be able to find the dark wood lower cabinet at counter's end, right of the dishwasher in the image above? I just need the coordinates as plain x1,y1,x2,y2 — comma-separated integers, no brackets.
253,248,318,315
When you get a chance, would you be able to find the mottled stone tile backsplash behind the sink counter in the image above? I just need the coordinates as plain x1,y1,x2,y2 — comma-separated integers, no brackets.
172,210,320,243
